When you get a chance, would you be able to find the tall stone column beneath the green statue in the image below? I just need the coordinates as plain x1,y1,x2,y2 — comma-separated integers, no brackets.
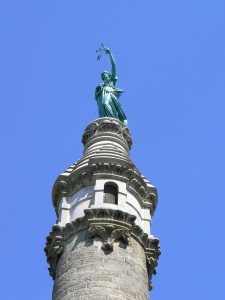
45,118,160,300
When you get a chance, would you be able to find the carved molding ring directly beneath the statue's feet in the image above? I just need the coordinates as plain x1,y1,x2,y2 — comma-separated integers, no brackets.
82,118,132,149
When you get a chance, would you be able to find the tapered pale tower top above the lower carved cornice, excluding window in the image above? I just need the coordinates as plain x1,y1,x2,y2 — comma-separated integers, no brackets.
52,118,158,234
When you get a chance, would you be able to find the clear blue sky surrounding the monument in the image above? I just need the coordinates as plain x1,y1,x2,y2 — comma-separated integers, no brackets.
0,0,225,300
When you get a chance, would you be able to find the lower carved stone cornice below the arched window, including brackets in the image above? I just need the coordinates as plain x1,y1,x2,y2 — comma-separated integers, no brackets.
44,209,160,289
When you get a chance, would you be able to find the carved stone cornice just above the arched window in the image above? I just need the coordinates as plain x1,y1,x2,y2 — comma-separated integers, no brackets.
52,159,158,215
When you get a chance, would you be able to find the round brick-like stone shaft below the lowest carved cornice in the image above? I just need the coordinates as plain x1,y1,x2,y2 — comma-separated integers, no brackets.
53,231,148,300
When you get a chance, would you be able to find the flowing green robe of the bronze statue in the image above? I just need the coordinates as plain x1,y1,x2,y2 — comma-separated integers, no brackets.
95,76,127,125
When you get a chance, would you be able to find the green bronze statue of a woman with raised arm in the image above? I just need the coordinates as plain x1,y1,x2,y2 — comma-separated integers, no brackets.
95,44,127,126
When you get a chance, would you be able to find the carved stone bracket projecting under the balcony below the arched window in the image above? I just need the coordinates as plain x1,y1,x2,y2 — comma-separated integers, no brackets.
88,225,130,252
